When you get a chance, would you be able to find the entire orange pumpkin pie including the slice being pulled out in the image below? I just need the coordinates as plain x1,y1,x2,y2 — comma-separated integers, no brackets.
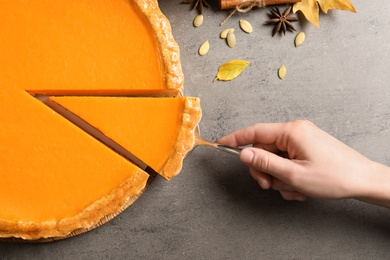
0,0,201,241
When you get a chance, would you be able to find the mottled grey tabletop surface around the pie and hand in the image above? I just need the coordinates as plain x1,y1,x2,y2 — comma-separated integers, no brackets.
0,0,390,259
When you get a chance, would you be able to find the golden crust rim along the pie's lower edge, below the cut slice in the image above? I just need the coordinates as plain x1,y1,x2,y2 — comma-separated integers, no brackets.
0,170,150,242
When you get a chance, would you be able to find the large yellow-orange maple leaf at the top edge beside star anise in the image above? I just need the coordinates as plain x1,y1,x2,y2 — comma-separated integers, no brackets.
293,0,356,28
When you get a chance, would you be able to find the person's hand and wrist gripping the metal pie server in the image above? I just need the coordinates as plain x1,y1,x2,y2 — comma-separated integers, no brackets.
218,121,390,206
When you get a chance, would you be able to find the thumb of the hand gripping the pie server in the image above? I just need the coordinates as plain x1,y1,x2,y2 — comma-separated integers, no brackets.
240,147,296,180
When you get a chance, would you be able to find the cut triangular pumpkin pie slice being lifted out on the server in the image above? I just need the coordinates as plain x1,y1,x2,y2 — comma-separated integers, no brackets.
51,97,200,179
